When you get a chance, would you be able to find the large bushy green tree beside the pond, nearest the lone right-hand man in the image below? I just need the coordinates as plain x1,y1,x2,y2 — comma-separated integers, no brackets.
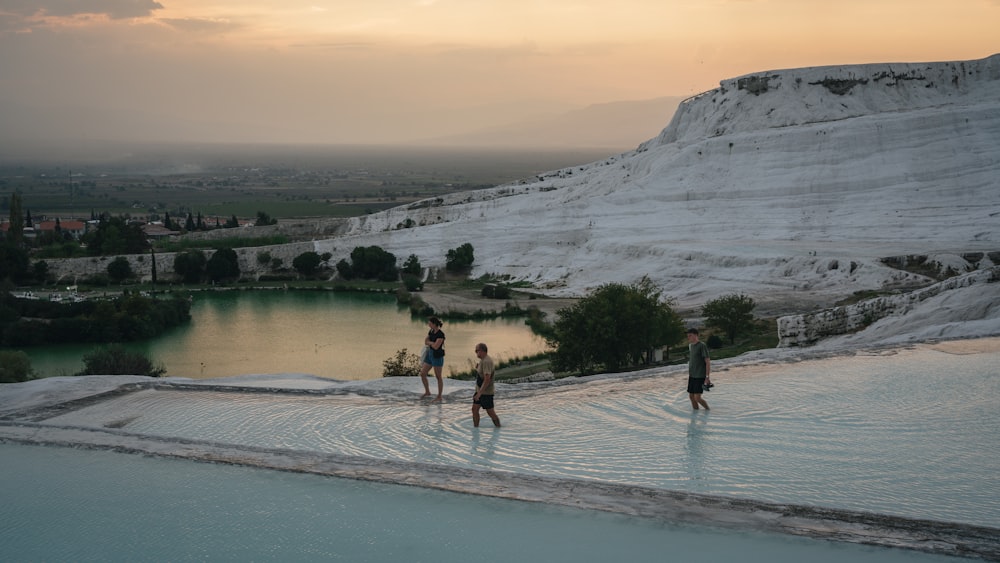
546,278,684,374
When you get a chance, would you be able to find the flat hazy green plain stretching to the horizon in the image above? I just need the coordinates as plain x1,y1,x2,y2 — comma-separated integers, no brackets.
0,145,608,226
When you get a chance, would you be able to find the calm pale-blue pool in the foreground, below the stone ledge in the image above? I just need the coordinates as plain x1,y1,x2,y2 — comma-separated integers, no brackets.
0,444,959,563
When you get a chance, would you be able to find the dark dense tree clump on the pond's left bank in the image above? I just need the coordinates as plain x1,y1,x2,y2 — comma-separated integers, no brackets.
0,292,191,348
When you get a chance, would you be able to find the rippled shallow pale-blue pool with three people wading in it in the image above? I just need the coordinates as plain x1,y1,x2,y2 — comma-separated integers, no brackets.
41,347,1000,527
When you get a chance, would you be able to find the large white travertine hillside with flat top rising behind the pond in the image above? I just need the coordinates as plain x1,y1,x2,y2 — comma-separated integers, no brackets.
315,55,1000,312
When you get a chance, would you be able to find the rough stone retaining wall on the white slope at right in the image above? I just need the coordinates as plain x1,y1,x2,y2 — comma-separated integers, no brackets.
778,266,1000,348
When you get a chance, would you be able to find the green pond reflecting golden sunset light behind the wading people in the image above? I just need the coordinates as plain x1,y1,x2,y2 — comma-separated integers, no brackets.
28,291,545,380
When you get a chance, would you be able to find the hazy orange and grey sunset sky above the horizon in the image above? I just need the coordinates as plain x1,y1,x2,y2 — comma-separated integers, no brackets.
0,0,1000,142
